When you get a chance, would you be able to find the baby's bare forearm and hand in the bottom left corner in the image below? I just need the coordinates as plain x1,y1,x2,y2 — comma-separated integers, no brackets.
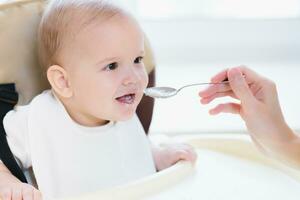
0,163,42,200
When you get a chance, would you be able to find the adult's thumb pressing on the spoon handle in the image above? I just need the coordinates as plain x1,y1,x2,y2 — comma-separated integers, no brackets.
227,68,255,104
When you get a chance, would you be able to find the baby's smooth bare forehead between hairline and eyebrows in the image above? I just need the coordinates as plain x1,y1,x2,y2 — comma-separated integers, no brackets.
64,13,144,60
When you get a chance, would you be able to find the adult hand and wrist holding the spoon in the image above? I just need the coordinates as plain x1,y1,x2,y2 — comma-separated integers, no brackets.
199,66,300,165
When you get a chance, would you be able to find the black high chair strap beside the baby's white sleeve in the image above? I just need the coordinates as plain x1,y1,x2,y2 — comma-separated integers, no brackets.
0,83,27,183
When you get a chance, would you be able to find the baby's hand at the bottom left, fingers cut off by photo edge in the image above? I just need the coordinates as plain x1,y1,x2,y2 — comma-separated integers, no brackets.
0,183,42,200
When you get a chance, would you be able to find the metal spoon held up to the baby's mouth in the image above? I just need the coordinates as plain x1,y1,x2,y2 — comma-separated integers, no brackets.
144,79,229,98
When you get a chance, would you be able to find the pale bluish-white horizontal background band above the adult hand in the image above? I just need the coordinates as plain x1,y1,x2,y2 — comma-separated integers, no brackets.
142,19,300,63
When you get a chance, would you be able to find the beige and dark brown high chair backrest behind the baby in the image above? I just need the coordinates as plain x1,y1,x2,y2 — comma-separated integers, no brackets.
0,0,155,183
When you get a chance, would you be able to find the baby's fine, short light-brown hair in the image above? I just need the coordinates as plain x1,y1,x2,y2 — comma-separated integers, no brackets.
38,0,128,72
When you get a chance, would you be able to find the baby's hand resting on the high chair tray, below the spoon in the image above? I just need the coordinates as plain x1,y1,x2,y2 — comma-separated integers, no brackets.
152,143,197,171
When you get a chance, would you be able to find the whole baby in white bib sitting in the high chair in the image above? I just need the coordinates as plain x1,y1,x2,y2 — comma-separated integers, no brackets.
0,0,196,200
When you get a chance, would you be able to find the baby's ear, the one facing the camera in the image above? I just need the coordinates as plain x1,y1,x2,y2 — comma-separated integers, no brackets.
47,65,73,98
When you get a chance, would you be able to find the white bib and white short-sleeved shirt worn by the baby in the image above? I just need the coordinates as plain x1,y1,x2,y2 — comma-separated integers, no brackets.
3,90,155,198
